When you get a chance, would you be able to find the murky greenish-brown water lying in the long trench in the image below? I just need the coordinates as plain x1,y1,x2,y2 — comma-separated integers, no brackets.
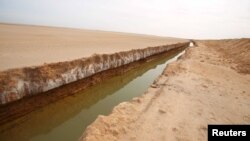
0,50,186,141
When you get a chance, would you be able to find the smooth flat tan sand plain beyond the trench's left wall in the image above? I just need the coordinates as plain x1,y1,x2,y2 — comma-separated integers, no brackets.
0,24,187,71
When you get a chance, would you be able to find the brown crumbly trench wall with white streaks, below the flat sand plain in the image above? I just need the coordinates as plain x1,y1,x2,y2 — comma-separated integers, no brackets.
0,42,189,105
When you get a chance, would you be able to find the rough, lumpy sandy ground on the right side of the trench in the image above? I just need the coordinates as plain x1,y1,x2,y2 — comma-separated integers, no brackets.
80,39,250,141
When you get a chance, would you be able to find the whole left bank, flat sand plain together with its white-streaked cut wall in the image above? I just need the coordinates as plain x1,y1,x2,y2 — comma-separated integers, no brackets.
0,24,189,105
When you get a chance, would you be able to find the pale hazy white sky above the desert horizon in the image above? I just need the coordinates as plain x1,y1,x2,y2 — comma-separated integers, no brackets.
0,0,250,38
